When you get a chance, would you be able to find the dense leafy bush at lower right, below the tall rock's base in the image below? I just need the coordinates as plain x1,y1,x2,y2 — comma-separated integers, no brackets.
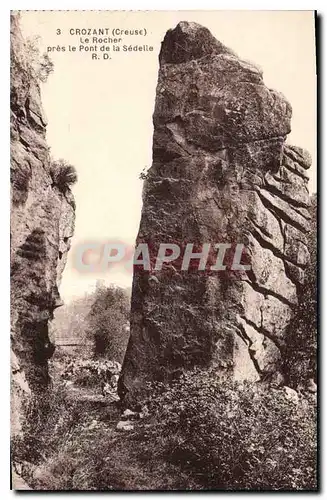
138,372,316,490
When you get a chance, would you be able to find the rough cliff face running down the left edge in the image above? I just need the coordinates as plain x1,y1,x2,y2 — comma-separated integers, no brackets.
10,15,75,435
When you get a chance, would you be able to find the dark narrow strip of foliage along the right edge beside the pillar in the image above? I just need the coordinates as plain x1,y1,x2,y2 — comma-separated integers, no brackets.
286,195,317,385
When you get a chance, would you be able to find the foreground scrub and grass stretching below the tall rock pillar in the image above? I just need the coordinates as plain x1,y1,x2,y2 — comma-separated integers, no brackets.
27,371,316,491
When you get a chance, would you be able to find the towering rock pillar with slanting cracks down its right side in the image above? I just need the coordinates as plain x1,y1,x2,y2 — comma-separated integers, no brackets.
120,22,311,399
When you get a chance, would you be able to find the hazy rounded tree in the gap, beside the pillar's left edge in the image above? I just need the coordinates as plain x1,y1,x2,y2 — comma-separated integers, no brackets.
87,286,130,363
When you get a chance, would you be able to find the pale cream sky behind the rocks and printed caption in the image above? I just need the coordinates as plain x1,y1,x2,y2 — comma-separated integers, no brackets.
21,11,317,302
